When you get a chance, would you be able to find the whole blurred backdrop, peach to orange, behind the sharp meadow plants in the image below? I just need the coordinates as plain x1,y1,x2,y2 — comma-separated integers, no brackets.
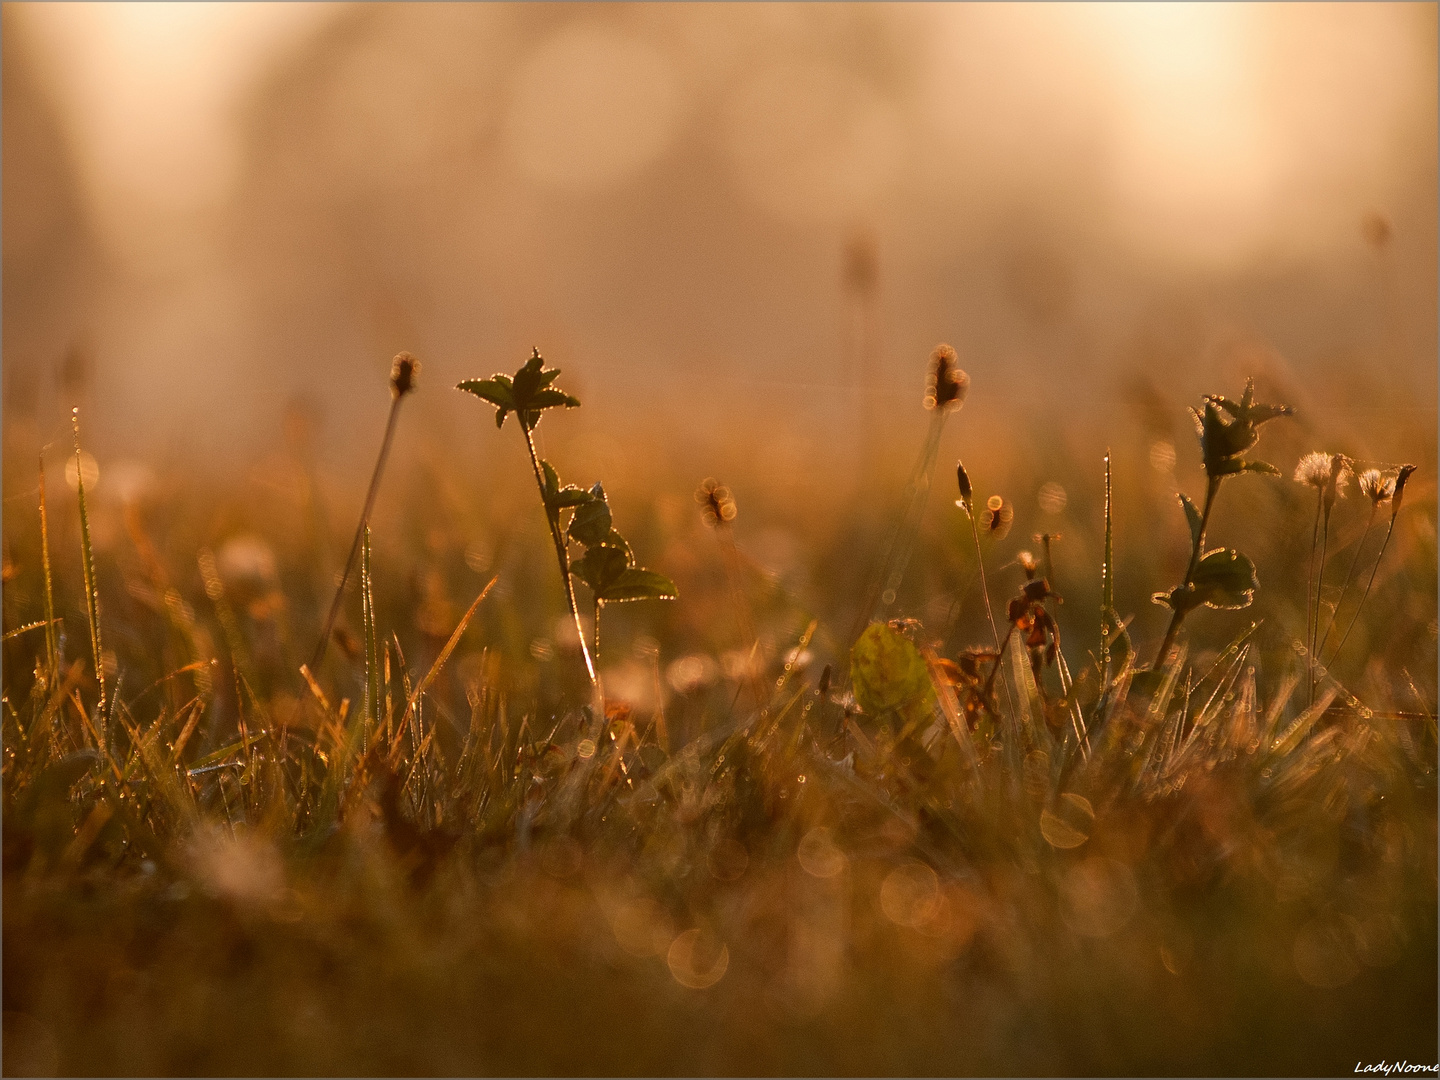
3,3,1437,694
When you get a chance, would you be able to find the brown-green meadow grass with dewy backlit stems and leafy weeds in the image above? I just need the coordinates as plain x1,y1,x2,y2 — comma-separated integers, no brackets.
3,350,1437,1074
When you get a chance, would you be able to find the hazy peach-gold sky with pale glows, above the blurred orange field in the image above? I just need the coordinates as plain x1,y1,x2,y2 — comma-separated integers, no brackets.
6,3,1436,478
